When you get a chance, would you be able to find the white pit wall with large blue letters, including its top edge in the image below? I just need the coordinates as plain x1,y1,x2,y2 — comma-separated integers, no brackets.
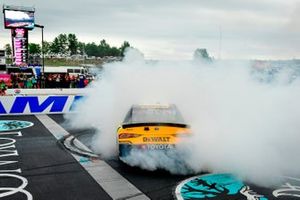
0,89,87,116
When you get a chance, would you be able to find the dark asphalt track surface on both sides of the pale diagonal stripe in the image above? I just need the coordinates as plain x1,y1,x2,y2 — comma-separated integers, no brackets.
0,115,300,200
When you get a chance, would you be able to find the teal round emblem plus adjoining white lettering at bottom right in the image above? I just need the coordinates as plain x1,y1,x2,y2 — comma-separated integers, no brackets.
175,174,300,200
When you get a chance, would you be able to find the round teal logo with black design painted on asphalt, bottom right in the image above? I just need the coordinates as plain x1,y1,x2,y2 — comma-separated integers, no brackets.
176,174,267,200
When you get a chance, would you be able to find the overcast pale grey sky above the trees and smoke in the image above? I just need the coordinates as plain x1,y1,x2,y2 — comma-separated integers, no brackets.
0,0,300,59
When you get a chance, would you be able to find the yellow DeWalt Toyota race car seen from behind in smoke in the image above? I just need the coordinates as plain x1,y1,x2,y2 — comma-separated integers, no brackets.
117,104,191,160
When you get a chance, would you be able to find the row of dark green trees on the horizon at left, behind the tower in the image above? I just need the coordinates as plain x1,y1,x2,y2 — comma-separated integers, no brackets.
5,33,130,57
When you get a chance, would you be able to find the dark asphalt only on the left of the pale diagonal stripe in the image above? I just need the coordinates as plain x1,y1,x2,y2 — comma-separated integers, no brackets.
0,116,111,200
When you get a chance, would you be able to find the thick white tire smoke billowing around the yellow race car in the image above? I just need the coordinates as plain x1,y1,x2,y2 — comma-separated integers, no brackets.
67,49,300,186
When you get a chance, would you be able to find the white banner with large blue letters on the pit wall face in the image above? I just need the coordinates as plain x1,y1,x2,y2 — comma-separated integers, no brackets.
0,95,83,115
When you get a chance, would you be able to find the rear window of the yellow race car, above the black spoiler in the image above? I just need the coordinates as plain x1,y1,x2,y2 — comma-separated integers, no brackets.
124,105,184,124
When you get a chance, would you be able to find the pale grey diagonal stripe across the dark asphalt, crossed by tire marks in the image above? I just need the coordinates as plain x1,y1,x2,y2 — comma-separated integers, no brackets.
36,115,150,200
